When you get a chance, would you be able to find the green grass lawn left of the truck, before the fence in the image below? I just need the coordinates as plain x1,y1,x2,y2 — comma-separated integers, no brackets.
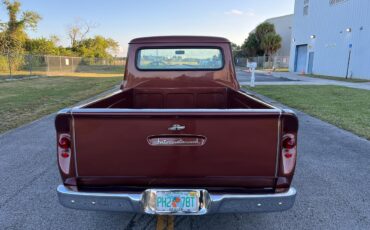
0,77,122,132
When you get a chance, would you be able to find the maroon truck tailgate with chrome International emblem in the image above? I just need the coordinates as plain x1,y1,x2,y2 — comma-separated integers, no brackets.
73,109,280,188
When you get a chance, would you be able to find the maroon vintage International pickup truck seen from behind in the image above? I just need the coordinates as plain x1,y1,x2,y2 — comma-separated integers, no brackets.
55,36,298,215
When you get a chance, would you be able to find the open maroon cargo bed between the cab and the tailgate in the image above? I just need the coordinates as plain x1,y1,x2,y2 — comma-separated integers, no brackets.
83,87,272,109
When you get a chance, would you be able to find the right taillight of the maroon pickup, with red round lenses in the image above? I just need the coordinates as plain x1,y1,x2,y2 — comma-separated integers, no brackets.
281,133,297,174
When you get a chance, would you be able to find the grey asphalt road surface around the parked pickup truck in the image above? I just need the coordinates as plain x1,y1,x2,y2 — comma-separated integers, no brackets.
0,89,370,230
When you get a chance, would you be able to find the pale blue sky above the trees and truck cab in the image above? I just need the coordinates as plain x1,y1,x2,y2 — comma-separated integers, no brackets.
0,0,294,56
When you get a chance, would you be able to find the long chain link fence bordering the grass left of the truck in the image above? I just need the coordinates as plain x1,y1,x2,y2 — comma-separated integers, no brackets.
0,55,126,79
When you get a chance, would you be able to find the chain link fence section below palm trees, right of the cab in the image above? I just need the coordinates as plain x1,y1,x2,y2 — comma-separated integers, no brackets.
235,56,289,69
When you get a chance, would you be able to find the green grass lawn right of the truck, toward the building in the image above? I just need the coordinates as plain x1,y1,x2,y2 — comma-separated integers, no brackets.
248,86,370,140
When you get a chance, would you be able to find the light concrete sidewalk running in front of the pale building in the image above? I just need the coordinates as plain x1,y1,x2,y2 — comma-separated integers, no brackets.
256,71,370,90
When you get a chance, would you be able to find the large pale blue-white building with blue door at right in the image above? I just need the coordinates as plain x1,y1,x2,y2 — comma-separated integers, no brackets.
289,0,370,79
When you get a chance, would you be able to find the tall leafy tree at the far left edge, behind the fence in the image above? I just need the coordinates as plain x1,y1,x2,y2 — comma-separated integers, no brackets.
0,0,41,77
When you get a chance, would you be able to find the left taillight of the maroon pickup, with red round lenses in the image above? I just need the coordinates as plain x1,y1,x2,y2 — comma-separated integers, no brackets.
58,133,72,174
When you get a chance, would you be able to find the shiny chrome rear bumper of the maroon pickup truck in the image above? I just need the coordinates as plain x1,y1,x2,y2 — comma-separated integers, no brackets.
57,185,296,215
